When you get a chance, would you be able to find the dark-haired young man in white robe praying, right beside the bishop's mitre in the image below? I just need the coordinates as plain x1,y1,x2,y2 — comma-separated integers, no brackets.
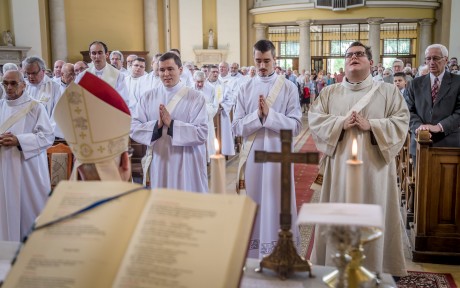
131,52,208,192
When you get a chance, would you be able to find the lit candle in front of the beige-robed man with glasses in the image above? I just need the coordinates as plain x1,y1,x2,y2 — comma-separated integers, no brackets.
345,139,363,203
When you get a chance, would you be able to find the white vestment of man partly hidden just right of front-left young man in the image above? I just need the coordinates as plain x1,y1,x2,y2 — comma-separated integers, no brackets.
195,82,219,162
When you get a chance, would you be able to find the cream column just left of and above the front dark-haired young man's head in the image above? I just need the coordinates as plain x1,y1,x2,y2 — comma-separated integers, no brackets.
144,0,160,66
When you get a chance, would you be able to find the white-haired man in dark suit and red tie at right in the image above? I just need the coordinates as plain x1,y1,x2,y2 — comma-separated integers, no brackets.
405,44,460,154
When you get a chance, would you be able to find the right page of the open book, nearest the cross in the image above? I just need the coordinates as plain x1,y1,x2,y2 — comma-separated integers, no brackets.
114,190,256,288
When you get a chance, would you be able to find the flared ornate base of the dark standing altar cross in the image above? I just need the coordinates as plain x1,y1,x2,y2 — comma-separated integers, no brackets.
256,230,313,280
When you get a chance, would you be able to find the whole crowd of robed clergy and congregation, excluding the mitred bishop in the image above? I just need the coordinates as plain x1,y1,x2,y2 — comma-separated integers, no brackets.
0,40,460,276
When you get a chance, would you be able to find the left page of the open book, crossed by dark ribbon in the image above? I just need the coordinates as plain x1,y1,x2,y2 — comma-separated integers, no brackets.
2,181,150,288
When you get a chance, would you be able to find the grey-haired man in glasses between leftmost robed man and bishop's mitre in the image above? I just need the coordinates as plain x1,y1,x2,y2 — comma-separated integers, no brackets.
23,56,61,117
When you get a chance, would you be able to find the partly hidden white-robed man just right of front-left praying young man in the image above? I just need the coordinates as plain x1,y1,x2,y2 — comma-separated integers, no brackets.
193,71,219,163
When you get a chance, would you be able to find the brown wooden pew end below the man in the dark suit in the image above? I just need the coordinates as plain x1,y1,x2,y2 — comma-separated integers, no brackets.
410,131,460,265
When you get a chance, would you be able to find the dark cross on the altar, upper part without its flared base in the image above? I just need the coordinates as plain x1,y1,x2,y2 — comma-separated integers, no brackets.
254,130,319,230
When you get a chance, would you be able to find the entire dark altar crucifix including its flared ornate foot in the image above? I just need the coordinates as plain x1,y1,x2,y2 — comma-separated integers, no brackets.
254,130,319,279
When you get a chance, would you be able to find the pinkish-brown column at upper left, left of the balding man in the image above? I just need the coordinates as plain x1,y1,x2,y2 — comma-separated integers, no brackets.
49,0,68,65
